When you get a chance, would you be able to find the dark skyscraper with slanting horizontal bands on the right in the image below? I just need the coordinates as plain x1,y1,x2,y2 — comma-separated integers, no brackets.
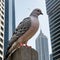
46,0,60,60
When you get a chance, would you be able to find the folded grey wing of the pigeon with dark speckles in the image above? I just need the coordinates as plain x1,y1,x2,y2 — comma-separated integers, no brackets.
9,17,31,46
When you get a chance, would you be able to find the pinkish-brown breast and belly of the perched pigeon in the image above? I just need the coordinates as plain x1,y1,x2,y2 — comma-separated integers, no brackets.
18,18,39,43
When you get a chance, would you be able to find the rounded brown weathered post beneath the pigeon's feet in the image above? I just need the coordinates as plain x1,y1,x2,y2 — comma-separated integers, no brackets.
7,46,38,60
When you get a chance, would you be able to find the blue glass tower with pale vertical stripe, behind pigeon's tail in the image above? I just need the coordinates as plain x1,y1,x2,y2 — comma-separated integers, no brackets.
4,0,15,54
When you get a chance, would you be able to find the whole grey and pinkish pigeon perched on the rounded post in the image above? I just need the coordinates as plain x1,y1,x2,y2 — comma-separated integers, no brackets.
8,8,43,57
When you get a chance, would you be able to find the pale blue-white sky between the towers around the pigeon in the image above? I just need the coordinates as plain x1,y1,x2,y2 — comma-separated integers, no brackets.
15,0,52,54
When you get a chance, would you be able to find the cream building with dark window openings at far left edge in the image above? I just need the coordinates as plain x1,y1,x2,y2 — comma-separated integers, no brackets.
0,0,5,60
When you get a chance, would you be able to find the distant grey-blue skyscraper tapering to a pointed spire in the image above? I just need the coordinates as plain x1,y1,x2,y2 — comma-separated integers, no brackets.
36,31,49,60
